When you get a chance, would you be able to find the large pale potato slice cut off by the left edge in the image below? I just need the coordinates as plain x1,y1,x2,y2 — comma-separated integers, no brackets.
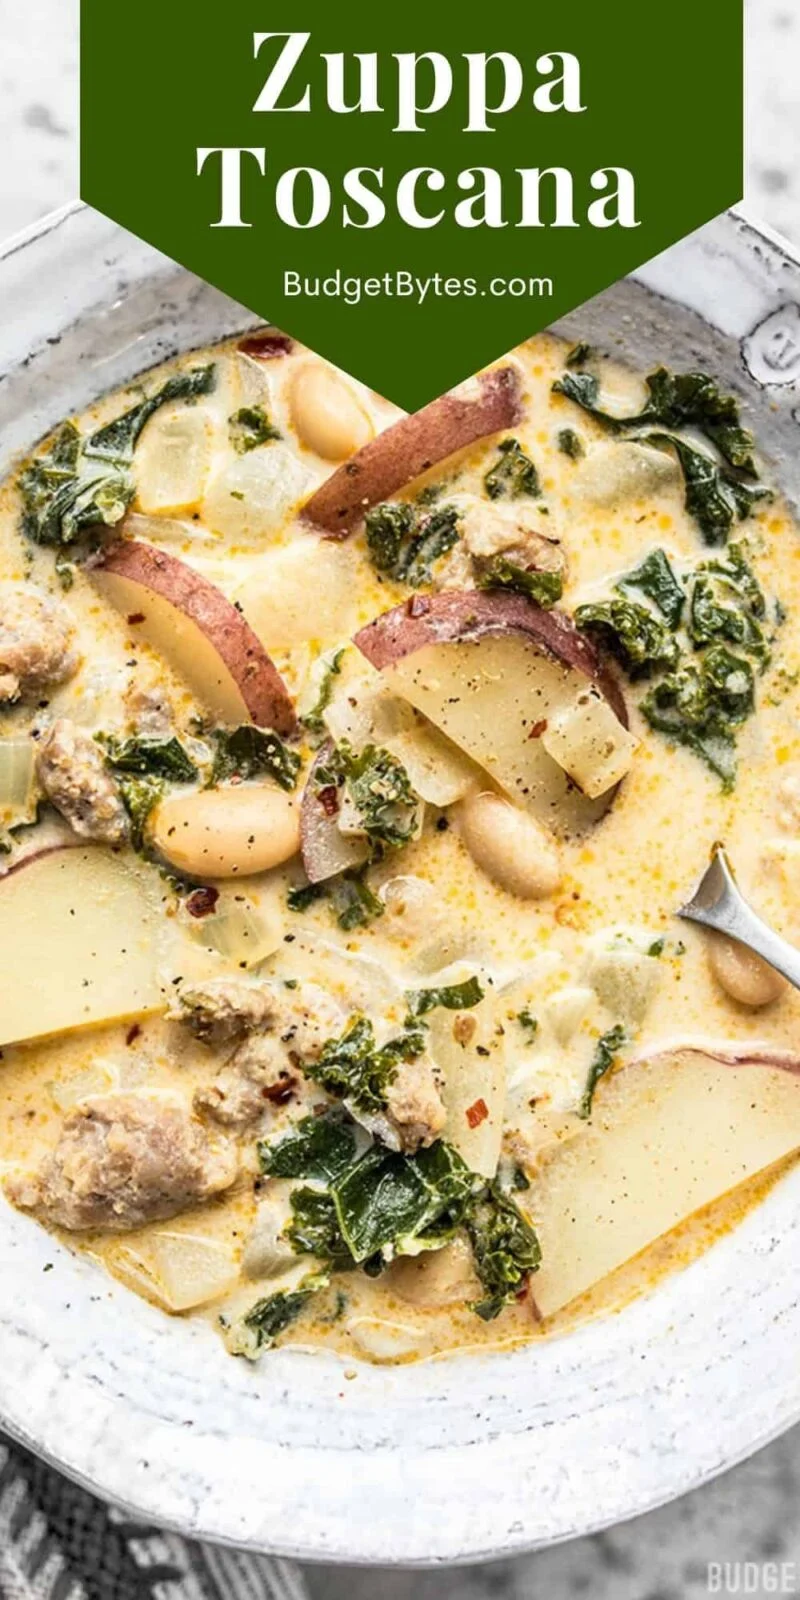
0,846,166,1045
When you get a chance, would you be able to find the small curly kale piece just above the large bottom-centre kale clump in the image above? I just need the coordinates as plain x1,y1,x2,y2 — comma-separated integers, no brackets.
302,1016,426,1112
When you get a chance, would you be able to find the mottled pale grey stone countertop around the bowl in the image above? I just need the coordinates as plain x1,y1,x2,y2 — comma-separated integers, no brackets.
0,0,800,1600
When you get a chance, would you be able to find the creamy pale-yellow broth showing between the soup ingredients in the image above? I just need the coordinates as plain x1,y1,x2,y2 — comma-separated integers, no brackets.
0,336,800,1360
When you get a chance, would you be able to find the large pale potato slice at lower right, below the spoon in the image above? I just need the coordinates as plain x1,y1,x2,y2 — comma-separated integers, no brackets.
522,1043,800,1317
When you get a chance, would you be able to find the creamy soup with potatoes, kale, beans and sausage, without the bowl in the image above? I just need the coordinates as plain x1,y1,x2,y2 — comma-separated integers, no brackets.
0,330,800,1360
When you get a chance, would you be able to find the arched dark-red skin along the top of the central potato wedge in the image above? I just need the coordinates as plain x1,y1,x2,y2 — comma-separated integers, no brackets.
354,589,627,728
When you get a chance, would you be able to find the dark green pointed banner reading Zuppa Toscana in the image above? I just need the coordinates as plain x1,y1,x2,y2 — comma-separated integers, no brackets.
82,0,742,410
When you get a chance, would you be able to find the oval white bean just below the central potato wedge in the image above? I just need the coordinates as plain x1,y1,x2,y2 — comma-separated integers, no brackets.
459,792,562,899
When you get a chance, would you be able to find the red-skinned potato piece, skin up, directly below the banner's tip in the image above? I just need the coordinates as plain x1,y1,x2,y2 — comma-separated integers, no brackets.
302,366,522,538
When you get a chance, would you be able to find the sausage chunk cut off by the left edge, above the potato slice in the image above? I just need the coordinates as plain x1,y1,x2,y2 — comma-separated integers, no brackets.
0,582,77,704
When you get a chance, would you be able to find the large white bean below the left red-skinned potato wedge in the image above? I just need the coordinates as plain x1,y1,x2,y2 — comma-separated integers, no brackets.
150,784,299,878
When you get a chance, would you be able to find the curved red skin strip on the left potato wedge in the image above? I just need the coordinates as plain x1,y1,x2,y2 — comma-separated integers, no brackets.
96,539,298,736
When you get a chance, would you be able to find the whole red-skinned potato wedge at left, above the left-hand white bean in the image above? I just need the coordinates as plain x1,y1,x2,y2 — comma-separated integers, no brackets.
91,539,298,734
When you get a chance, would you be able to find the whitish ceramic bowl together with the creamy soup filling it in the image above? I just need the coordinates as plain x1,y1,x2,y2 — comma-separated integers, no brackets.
0,206,800,1563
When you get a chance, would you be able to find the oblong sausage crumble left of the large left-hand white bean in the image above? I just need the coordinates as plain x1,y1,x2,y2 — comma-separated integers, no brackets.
37,717,128,845
